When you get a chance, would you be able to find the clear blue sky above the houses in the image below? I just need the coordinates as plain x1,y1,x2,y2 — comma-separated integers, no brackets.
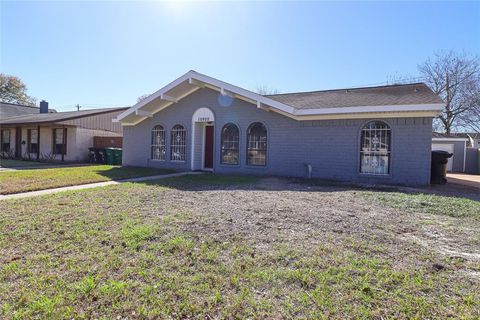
0,1,480,111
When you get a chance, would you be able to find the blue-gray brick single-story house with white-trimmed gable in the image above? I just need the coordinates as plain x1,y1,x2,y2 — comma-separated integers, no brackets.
116,71,444,184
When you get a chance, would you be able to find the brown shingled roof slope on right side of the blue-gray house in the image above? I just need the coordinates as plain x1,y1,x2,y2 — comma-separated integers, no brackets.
266,83,443,109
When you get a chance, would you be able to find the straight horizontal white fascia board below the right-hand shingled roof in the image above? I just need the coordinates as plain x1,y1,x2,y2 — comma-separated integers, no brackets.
295,103,444,116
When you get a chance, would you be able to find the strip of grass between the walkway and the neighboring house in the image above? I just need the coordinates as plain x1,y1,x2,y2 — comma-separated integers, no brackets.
0,165,172,194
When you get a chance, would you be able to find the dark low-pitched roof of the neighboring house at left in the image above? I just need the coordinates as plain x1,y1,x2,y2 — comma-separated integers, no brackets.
0,108,128,125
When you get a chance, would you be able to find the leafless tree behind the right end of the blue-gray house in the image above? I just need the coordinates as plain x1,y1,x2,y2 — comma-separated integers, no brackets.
418,51,480,133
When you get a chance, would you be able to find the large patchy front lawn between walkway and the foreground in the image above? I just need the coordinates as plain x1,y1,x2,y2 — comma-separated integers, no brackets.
0,175,480,319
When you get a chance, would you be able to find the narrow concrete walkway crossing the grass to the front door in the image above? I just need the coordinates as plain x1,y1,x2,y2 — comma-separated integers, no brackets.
0,172,203,201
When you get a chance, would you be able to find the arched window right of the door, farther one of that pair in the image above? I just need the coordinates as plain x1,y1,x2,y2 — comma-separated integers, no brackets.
247,122,267,166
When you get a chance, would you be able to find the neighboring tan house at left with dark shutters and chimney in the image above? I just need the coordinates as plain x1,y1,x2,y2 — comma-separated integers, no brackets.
0,101,126,161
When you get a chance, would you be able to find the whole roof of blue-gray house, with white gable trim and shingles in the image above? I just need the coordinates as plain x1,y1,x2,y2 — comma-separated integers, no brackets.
116,70,444,125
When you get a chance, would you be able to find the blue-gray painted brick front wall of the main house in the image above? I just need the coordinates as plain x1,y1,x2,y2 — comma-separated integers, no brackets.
123,89,432,185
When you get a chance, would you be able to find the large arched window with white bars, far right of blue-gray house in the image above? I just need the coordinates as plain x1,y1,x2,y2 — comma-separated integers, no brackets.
360,121,391,174
